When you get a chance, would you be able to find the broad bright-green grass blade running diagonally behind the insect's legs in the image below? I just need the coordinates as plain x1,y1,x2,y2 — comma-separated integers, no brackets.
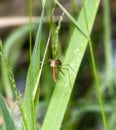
42,0,100,130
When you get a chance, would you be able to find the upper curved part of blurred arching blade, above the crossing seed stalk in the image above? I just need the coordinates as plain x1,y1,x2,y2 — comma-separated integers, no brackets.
4,24,37,66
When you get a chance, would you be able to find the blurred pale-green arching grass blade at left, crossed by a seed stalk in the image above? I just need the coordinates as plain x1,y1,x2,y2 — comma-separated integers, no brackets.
1,25,36,99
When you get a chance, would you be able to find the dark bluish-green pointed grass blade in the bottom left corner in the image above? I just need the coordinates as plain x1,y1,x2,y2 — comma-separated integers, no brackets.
0,94,15,130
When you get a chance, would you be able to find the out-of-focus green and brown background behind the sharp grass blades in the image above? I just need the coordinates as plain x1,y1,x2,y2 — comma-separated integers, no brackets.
0,0,116,130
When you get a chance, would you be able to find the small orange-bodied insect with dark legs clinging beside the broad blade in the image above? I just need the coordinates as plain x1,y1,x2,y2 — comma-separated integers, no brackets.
49,59,64,81
